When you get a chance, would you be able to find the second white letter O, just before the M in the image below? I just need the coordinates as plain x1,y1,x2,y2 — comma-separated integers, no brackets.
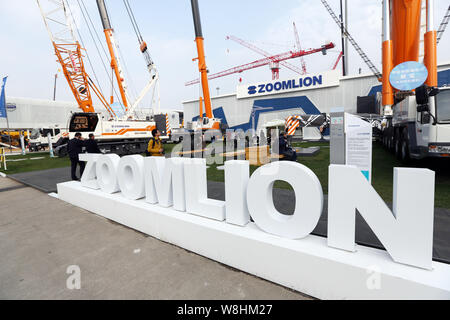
117,155,145,200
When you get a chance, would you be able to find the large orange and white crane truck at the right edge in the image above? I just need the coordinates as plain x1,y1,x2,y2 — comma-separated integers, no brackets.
382,0,450,160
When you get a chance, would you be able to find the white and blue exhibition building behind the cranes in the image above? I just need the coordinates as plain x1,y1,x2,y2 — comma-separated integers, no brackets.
183,62,450,139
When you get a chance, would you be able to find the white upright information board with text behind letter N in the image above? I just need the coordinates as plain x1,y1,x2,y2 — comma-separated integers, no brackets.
345,113,372,182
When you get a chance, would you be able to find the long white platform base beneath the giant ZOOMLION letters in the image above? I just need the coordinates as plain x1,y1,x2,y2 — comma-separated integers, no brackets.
58,182,450,299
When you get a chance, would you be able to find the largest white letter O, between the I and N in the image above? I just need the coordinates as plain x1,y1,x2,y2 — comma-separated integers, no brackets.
247,162,323,239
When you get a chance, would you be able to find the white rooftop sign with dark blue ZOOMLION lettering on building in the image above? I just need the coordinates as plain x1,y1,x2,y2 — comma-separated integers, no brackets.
237,70,340,99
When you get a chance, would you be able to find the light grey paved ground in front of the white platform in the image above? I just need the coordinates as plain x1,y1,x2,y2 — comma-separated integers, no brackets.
0,178,308,300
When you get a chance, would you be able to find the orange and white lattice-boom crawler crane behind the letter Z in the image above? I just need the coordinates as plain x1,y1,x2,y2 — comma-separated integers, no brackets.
36,0,159,155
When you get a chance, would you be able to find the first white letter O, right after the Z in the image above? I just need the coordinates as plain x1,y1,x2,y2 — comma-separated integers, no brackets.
95,154,120,193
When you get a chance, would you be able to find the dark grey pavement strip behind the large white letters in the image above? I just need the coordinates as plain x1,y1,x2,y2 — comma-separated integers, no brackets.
11,168,450,263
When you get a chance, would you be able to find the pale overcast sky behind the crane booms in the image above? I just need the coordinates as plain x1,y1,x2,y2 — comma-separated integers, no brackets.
0,0,450,109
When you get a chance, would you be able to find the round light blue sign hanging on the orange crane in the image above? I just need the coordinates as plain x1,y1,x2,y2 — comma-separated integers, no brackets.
389,61,428,91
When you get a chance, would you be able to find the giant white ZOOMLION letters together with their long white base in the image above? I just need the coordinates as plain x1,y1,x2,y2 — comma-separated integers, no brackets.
58,154,450,299
